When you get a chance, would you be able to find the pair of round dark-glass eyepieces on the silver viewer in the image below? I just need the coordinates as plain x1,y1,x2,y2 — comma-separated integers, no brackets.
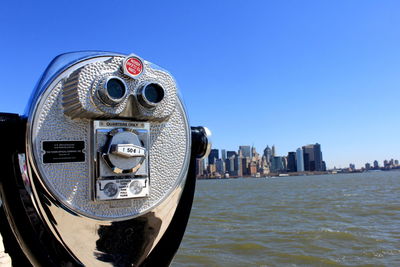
98,77,165,108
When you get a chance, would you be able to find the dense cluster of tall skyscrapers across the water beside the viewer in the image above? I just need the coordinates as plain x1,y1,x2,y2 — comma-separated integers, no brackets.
200,143,327,178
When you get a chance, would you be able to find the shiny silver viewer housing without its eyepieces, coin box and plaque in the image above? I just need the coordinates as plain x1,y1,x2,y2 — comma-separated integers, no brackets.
18,53,191,266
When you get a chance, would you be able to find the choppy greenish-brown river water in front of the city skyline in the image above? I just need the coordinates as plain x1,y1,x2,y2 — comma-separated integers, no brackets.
171,171,400,266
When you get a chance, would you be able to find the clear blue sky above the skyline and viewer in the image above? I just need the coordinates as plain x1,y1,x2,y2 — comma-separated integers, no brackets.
0,0,400,167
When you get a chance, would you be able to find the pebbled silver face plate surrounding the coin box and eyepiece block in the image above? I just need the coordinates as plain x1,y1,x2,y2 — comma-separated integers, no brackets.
29,52,190,220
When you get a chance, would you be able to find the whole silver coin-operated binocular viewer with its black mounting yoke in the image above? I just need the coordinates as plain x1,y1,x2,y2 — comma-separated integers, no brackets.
0,52,210,266
